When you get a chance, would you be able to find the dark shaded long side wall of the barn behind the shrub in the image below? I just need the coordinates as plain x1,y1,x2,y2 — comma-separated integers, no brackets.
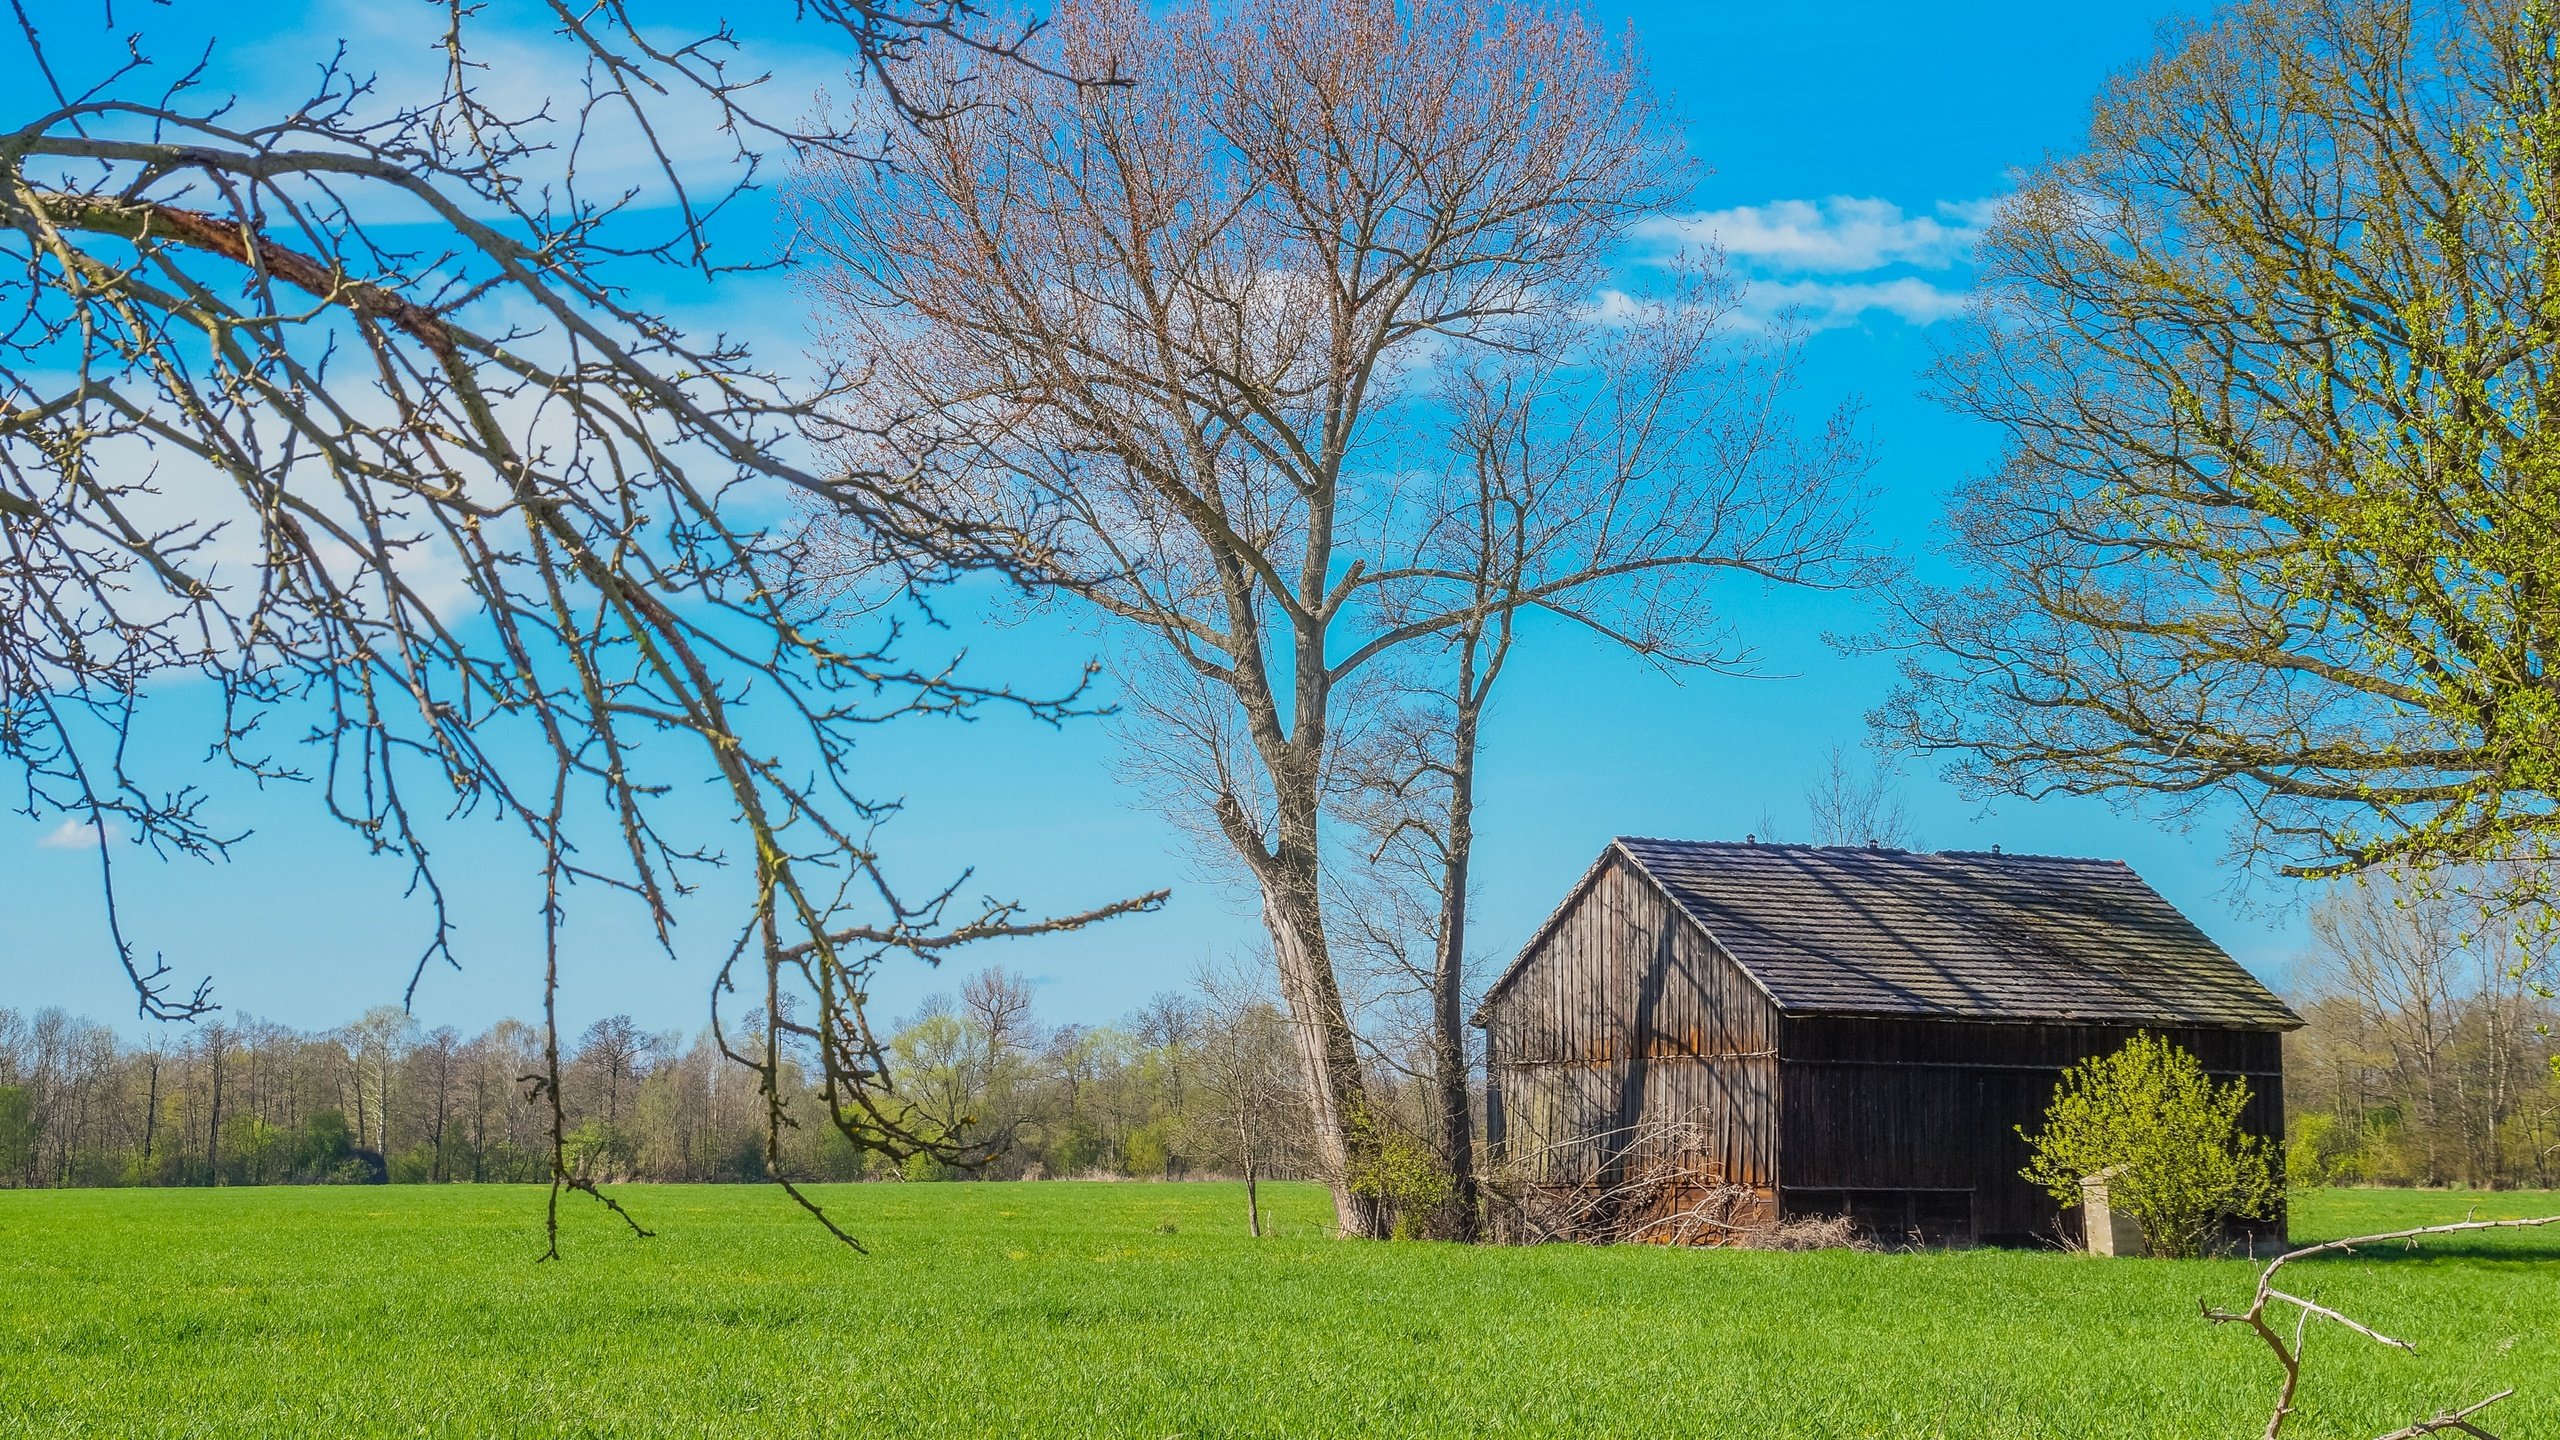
1779,1017,2284,1243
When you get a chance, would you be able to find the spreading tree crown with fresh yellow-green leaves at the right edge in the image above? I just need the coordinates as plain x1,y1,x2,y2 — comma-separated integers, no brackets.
1882,0,2560,876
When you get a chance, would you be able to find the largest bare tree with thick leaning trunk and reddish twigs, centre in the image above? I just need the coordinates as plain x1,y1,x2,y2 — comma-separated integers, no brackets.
809,0,1884,1235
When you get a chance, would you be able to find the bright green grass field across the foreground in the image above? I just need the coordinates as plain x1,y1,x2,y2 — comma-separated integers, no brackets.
0,1184,2560,1437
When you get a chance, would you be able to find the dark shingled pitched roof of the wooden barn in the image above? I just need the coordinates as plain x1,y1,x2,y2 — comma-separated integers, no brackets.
1487,838,2301,1030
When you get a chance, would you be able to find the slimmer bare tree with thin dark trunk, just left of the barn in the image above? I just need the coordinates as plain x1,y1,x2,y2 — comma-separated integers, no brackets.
1352,269,1882,1235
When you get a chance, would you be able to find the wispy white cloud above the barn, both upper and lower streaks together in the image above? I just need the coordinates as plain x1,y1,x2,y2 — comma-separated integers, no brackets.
1603,195,1999,331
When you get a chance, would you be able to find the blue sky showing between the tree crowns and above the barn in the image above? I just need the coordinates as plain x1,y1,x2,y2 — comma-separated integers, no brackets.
0,3,2299,1030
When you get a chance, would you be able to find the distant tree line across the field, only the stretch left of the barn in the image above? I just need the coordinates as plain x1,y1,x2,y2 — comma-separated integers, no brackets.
0,969,1303,1186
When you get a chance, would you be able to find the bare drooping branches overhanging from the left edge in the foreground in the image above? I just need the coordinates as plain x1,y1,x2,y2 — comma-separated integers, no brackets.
0,0,1126,1245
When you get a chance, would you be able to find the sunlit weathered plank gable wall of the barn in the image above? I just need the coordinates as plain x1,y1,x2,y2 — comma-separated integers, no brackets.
1485,856,1777,1199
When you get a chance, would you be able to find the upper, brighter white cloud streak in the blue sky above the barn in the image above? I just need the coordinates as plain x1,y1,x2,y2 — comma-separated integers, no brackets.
1641,195,1999,274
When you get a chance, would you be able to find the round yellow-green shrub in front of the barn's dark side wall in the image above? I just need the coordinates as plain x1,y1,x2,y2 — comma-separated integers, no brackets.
2017,1035,2284,1258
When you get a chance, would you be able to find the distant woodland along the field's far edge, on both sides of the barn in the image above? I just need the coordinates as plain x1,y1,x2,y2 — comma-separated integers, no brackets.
15,860,2560,1186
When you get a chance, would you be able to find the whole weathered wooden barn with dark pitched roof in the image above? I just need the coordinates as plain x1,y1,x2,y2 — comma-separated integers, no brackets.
1475,838,2301,1243
